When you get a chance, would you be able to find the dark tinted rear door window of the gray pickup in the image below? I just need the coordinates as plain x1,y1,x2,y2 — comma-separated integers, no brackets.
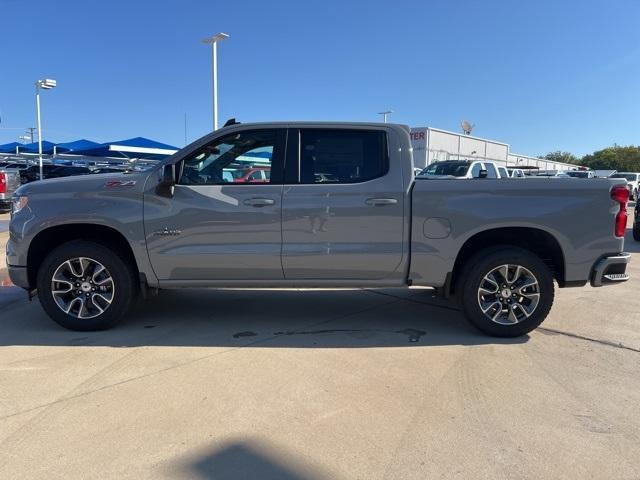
300,129,389,183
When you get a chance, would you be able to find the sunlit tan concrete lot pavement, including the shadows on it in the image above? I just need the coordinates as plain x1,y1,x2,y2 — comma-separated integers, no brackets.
0,211,640,480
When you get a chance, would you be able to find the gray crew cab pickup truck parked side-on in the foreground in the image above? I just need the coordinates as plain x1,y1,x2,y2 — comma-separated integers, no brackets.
7,122,630,336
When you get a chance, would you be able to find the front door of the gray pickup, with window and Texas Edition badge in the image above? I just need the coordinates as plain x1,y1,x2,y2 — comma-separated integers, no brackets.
145,129,286,285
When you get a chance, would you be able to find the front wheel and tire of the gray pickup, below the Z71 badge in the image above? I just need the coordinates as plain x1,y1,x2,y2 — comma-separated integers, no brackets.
37,240,138,331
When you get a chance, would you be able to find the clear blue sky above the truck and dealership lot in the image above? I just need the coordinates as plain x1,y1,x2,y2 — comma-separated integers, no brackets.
0,0,640,155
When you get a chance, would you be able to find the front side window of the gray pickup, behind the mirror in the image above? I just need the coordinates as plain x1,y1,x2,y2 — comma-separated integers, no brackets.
179,130,277,185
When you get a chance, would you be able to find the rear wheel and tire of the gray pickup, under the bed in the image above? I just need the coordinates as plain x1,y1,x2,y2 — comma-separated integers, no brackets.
460,245,554,337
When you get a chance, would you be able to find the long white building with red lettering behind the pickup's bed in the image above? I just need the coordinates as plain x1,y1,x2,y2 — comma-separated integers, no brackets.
411,127,576,170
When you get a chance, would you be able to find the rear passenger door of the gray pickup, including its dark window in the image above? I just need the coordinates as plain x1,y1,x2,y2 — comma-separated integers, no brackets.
282,128,405,281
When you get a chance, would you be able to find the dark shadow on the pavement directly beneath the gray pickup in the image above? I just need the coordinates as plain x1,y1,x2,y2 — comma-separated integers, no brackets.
0,289,528,348
